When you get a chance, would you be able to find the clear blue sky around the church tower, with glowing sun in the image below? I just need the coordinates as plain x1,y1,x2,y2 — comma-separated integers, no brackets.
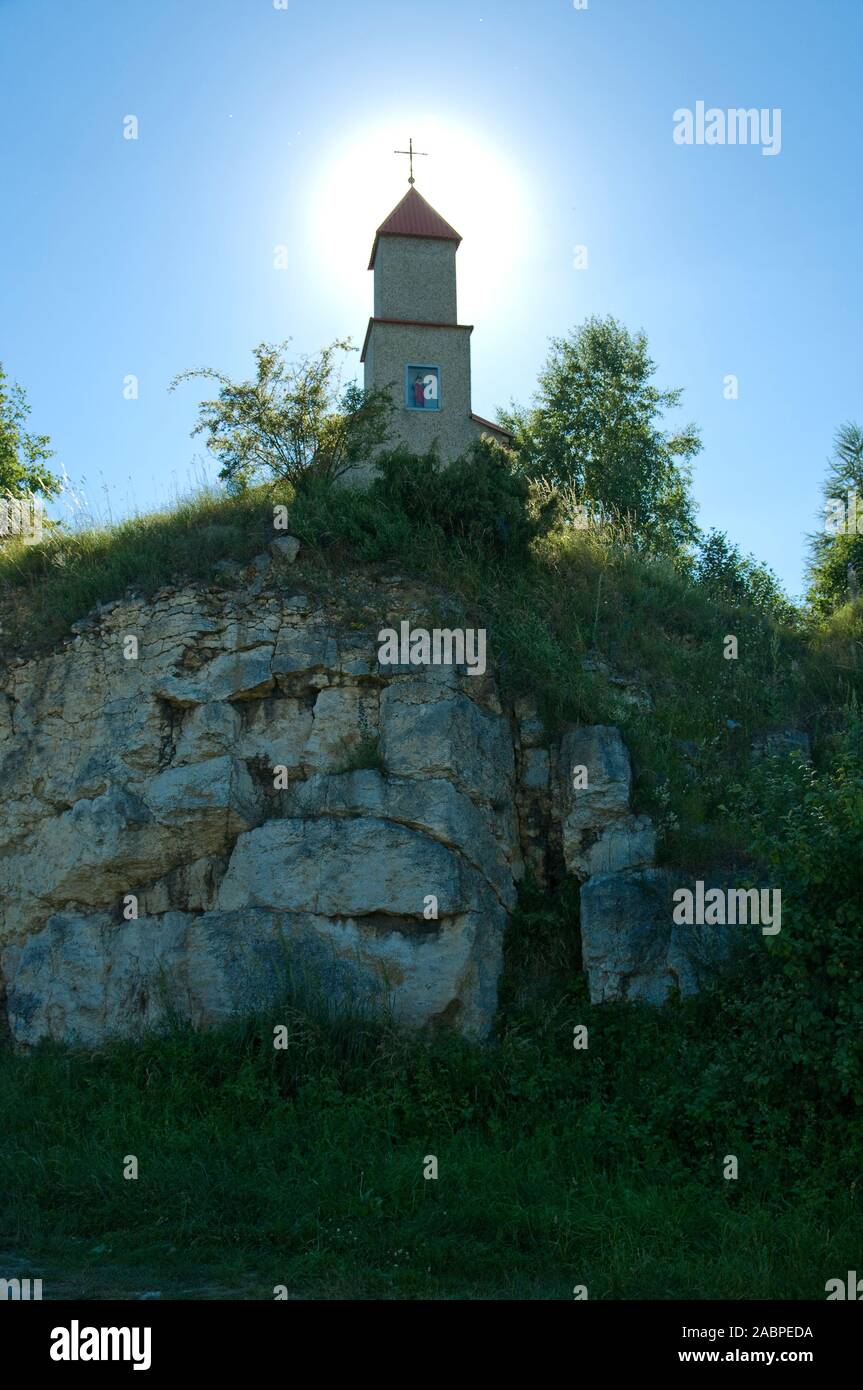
0,0,863,592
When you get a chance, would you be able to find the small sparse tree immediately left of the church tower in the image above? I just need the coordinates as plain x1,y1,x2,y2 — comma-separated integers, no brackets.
168,339,393,492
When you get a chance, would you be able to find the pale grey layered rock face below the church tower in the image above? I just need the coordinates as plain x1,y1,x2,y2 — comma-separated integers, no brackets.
0,538,689,1047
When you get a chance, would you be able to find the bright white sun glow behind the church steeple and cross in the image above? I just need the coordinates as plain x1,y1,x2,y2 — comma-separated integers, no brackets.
310,117,531,322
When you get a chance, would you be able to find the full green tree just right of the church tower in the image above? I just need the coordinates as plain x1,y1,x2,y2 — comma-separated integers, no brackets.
502,317,702,553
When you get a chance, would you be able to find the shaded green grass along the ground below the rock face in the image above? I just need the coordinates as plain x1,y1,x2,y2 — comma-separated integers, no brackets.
0,950,862,1298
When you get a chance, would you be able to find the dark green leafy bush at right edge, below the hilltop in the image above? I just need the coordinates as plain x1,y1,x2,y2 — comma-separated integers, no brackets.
652,723,863,1173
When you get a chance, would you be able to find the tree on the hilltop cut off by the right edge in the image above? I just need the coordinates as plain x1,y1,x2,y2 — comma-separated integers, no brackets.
809,420,863,614
